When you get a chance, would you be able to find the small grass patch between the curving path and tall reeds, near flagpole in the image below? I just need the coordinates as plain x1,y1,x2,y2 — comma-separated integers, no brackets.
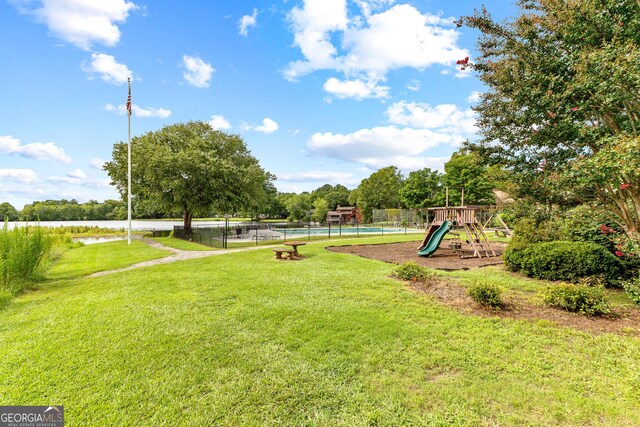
47,240,170,279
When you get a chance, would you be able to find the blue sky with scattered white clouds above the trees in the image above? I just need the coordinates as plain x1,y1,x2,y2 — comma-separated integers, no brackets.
0,0,516,208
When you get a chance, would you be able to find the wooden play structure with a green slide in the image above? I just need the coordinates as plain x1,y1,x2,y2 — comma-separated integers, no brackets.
418,206,506,258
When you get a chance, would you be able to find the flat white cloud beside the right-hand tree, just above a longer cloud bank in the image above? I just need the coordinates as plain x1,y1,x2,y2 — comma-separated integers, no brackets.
386,101,478,136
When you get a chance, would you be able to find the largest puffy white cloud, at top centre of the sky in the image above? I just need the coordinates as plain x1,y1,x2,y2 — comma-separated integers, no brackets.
284,0,469,99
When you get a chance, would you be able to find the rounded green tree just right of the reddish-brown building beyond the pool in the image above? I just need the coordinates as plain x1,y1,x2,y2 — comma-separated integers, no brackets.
350,166,403,222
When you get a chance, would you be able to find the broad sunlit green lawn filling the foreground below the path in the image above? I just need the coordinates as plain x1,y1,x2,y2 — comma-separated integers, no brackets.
0,238,640,426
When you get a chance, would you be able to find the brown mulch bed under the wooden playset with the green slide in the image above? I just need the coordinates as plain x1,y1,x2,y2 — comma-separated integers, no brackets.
327,240,505,270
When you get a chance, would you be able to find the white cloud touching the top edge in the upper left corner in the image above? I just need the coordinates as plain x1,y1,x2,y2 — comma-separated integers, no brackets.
11,0,137,50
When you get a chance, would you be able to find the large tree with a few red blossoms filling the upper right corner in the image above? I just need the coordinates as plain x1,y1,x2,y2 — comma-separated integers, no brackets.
460,0,640,239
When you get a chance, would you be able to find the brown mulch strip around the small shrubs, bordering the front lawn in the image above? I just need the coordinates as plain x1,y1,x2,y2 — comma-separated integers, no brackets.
409,280,640,337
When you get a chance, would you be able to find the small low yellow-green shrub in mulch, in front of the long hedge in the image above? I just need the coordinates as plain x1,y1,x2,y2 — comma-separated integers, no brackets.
542,283,611,316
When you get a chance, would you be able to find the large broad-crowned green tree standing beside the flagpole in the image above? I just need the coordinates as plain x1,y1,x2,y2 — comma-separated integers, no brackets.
104,121,271,230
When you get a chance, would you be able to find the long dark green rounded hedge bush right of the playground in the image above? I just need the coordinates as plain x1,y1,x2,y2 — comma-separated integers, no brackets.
503,241,624,284
